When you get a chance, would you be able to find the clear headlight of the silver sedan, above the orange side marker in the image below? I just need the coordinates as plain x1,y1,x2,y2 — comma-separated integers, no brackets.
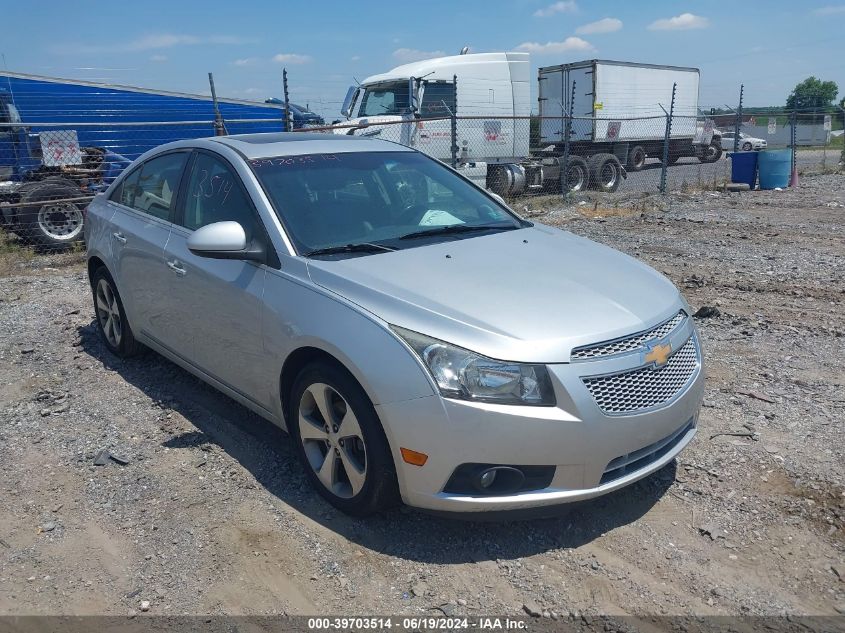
391,326,555,406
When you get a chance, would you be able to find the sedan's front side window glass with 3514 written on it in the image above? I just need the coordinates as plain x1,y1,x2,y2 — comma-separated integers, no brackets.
182,153,258,241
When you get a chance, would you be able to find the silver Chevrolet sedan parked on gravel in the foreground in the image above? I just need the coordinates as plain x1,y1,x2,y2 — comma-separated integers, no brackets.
85,134,703,515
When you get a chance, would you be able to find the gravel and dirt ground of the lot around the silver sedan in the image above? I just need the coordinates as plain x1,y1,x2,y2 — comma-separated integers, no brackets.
0,175,845,619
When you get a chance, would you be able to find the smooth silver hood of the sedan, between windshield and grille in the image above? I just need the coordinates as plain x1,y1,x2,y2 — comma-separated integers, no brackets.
307,225,685,363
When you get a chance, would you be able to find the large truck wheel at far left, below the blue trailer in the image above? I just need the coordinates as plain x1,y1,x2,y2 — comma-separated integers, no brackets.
18,180,86,250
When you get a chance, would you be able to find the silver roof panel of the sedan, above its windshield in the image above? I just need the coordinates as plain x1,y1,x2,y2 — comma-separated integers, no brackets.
205,132,414,160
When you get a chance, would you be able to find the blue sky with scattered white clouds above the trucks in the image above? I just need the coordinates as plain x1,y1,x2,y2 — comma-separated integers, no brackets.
0,0,845,120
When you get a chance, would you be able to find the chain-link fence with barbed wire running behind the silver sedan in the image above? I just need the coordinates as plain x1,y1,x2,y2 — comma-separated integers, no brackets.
0,84,845,250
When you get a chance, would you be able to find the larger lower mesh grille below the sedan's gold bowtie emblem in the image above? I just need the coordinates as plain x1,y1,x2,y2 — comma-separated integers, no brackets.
581,335,700,415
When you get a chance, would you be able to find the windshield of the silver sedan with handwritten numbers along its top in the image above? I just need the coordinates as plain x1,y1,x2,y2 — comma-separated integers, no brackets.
250,152,528,257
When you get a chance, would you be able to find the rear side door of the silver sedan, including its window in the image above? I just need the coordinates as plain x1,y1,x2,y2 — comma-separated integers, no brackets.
110,151,189,340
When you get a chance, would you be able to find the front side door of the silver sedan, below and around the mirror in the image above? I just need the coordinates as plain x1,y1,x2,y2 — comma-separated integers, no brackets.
165,151,272,407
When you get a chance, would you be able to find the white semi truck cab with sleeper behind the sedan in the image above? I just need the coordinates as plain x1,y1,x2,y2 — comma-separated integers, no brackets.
336,53,531,172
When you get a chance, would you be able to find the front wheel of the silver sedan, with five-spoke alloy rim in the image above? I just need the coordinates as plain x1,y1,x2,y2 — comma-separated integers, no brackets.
287,361,399,517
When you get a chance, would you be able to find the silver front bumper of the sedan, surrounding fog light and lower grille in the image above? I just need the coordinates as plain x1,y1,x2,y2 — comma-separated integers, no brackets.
376,318,704,512
